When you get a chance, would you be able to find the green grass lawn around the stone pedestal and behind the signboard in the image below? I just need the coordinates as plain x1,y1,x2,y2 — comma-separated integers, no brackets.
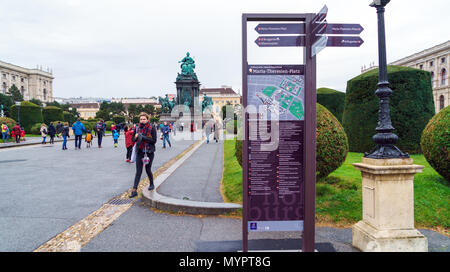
222,140,450,235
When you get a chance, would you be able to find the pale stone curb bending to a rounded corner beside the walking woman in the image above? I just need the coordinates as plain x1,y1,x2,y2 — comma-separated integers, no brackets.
141,141,242,215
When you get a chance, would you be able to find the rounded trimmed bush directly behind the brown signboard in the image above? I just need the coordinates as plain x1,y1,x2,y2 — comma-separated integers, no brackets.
235,104,348,179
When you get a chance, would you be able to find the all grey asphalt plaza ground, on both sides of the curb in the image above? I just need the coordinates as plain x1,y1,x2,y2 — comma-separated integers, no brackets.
0,133,450,252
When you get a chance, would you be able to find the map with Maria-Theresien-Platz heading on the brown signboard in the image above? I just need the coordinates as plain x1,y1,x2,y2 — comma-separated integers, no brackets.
247,65,305,120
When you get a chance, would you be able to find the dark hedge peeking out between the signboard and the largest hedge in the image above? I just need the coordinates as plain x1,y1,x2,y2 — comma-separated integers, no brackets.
317,88,345,124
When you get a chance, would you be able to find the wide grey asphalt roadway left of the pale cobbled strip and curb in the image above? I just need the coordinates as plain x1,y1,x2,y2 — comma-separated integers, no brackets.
0,134,194,251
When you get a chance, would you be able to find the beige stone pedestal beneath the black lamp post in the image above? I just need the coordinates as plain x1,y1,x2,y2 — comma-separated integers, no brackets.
352,158,428,252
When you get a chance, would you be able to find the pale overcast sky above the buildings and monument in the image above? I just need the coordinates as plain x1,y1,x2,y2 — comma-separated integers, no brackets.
0,0,450,97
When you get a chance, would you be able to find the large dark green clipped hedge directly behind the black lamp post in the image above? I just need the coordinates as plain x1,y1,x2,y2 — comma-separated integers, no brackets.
343,66,434,153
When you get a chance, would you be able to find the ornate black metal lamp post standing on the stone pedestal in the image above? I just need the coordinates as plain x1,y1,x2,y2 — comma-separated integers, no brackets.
364,0,409,159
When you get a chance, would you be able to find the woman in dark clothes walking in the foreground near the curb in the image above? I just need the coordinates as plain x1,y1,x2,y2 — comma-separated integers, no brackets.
130,112,157,198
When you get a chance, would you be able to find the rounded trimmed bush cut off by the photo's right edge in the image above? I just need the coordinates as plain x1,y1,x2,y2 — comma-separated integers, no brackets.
420,106,450,181
